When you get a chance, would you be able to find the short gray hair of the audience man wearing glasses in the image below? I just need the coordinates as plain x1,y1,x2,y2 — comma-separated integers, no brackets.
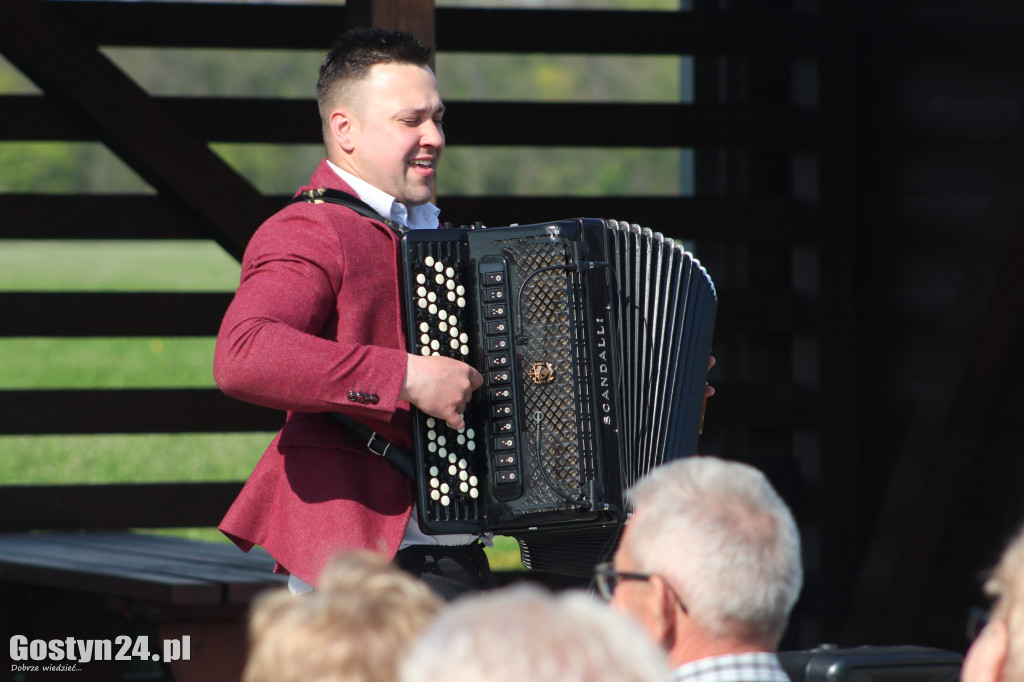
625,457,803,647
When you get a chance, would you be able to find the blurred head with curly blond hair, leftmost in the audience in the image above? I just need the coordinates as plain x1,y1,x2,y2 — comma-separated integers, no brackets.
243,552,441,682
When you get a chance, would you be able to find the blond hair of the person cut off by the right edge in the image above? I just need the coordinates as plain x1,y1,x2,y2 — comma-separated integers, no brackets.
985,528,1024,682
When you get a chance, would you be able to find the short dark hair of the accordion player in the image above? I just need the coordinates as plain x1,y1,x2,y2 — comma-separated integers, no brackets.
316,29,433,106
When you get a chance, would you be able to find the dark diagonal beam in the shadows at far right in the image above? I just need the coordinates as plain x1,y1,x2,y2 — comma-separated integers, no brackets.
843,107,1024,644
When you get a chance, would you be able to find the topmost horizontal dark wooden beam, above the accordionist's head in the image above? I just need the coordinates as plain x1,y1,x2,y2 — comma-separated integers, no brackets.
37,0,806,57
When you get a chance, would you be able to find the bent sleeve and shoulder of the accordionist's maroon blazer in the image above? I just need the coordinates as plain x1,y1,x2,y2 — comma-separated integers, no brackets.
214,205,408,421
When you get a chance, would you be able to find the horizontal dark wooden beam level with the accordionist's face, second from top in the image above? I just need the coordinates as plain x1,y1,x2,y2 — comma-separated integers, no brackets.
0,95,790,151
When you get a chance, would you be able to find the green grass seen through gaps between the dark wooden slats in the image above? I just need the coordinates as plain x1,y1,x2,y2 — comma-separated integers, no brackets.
0,241,522,569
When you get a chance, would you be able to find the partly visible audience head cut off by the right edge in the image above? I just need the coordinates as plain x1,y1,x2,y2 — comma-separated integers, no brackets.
961,528,1024,682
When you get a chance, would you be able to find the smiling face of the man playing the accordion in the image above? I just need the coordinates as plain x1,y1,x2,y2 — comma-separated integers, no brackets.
331,63,444,206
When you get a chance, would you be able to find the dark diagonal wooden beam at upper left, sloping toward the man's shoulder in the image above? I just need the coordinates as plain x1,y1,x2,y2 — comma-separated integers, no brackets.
0,0,275,258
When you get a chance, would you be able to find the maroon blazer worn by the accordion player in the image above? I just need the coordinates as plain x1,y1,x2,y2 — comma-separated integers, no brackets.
214,160,425,585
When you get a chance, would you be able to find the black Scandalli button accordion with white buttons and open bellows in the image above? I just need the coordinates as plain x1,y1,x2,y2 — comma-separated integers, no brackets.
402,219,717,576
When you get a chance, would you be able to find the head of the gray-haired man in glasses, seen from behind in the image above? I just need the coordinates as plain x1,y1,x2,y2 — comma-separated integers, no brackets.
599,457,803,666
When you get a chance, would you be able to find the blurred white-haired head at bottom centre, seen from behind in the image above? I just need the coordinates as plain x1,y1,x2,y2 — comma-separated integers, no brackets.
400,586,669,682
